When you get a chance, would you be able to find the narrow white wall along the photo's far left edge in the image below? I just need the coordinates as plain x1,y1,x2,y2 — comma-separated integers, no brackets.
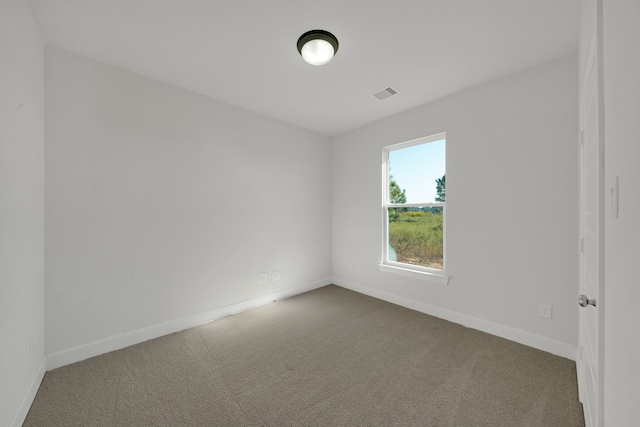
0,0,45,426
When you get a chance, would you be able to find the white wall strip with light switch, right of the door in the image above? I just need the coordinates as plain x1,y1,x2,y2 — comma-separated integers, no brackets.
602,0,640,426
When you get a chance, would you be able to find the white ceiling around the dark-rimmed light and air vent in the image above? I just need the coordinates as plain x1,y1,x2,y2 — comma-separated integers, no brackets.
29,0,582,136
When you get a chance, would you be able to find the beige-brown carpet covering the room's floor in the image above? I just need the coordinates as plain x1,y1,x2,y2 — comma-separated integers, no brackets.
24,286,584,427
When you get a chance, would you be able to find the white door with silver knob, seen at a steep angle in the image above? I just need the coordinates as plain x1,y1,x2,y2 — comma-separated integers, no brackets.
578,36,604,427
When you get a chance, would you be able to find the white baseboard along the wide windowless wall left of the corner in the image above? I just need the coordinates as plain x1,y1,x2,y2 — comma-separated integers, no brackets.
47,278,331,371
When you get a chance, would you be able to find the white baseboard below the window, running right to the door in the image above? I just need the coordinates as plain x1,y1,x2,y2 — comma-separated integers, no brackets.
333,277,578,361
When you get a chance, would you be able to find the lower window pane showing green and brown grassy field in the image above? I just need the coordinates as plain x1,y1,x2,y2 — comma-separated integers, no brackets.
388,207,444,270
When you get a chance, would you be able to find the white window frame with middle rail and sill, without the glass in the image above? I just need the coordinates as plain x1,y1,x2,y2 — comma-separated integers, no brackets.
379,132,449,285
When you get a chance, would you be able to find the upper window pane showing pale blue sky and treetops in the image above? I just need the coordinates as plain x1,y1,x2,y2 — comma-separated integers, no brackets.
389,139,446,203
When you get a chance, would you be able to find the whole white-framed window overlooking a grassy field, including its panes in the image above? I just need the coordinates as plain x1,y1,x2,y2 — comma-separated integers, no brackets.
381,133,446,281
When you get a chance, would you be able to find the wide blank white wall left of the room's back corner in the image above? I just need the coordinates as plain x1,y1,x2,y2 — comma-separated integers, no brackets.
45,47,331,361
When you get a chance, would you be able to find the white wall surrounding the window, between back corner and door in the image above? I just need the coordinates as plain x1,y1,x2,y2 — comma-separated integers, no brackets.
332,55,578,358
